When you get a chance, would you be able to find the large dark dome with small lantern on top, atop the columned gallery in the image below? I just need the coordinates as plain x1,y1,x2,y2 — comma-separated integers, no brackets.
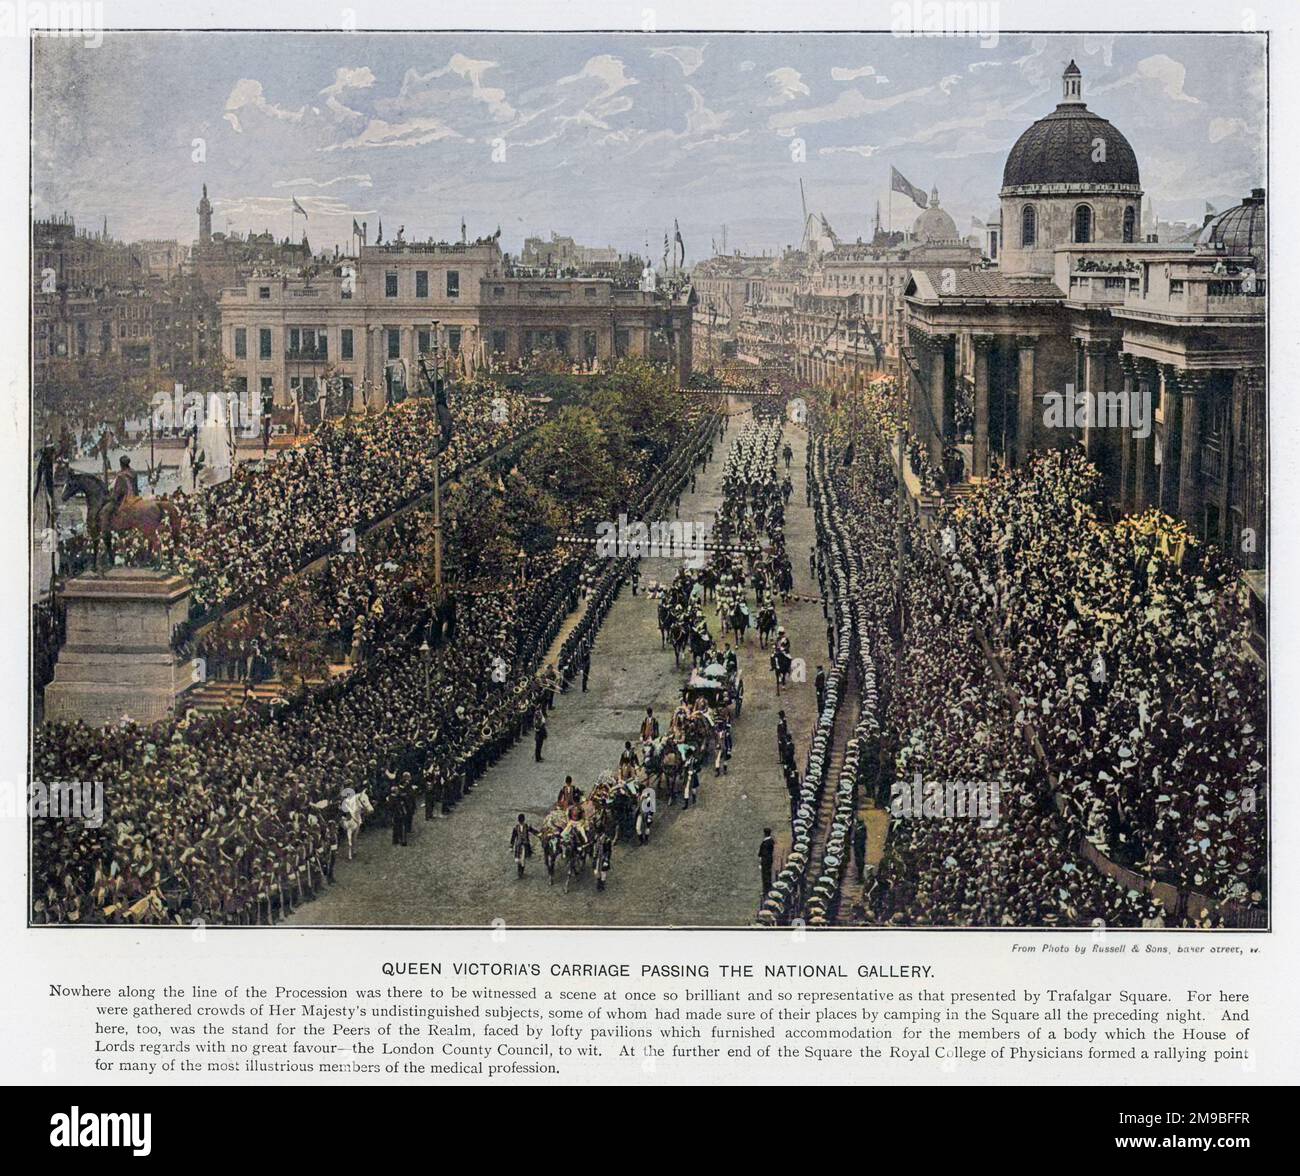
1002,61,1141,188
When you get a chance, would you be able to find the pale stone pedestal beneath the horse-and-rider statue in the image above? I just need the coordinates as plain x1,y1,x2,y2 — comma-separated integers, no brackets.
46,568,194,726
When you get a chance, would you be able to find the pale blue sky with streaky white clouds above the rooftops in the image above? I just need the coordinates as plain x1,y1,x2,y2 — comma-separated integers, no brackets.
33,32,1268,264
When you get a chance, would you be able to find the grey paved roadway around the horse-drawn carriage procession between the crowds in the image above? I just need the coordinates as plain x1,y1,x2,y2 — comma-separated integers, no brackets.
289,402,826,927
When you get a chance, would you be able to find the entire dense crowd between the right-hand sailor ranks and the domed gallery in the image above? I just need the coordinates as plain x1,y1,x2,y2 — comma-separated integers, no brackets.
818,382,1266,925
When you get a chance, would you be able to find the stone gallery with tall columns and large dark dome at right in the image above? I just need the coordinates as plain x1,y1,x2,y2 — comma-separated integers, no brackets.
901,62,1268,568
